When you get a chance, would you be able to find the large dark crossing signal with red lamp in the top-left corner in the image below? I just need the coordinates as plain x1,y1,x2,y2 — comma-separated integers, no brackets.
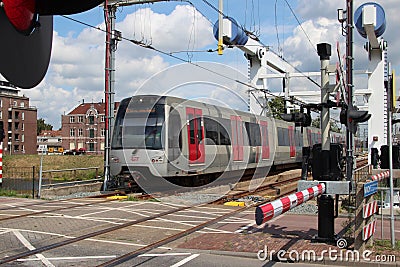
0,0,104,88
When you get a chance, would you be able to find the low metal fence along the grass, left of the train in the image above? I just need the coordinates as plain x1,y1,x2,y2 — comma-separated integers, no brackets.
2,166,103,197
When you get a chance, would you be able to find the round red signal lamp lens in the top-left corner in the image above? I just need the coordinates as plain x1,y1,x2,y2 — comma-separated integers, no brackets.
2,0,37,35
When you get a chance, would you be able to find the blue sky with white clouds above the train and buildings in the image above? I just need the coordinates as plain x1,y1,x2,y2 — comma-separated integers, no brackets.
7,0,400,129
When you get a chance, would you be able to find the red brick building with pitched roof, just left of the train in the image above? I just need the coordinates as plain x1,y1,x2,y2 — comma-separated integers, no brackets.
61,102,119,154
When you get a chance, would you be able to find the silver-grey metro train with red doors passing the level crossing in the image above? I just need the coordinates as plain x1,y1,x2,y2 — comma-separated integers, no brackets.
106,95,362,190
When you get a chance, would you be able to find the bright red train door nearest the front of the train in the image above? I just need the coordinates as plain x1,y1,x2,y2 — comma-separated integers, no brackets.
186,108,205,164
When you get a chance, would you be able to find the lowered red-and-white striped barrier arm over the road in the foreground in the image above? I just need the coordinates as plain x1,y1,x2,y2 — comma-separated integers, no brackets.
256,184,325,225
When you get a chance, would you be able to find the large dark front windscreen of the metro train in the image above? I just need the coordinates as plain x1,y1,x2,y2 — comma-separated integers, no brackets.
111,97,165,150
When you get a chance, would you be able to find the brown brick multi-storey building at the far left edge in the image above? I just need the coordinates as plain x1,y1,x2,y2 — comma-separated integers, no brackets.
0,81,37,155
